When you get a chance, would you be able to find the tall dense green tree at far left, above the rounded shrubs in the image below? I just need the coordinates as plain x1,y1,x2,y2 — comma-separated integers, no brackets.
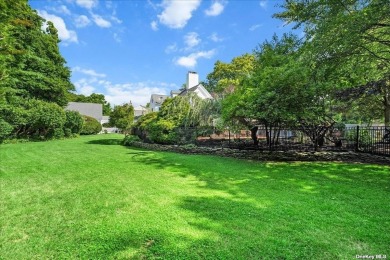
0,0,74,106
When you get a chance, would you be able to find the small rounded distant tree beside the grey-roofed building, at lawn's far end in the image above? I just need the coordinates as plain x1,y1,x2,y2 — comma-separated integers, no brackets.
109,102,134,131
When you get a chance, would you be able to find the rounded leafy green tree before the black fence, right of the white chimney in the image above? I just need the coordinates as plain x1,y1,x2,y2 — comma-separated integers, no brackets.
222,35,307,145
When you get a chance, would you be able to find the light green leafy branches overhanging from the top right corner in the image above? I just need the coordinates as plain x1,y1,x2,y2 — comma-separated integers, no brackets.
275,0,390,126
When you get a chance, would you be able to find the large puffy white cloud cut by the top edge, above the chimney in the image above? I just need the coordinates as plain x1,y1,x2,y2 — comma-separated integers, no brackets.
158,0,201,29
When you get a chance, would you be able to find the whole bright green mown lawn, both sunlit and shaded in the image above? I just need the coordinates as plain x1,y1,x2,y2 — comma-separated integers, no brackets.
0,135,390,259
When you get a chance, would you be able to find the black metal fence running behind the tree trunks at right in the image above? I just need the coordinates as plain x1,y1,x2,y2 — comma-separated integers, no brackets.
187,126,390,156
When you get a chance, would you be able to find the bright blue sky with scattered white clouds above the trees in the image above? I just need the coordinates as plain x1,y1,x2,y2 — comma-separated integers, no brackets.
29,0,291,106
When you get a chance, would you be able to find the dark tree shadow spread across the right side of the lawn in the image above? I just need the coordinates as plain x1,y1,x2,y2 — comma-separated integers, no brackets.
119,150,390,259
